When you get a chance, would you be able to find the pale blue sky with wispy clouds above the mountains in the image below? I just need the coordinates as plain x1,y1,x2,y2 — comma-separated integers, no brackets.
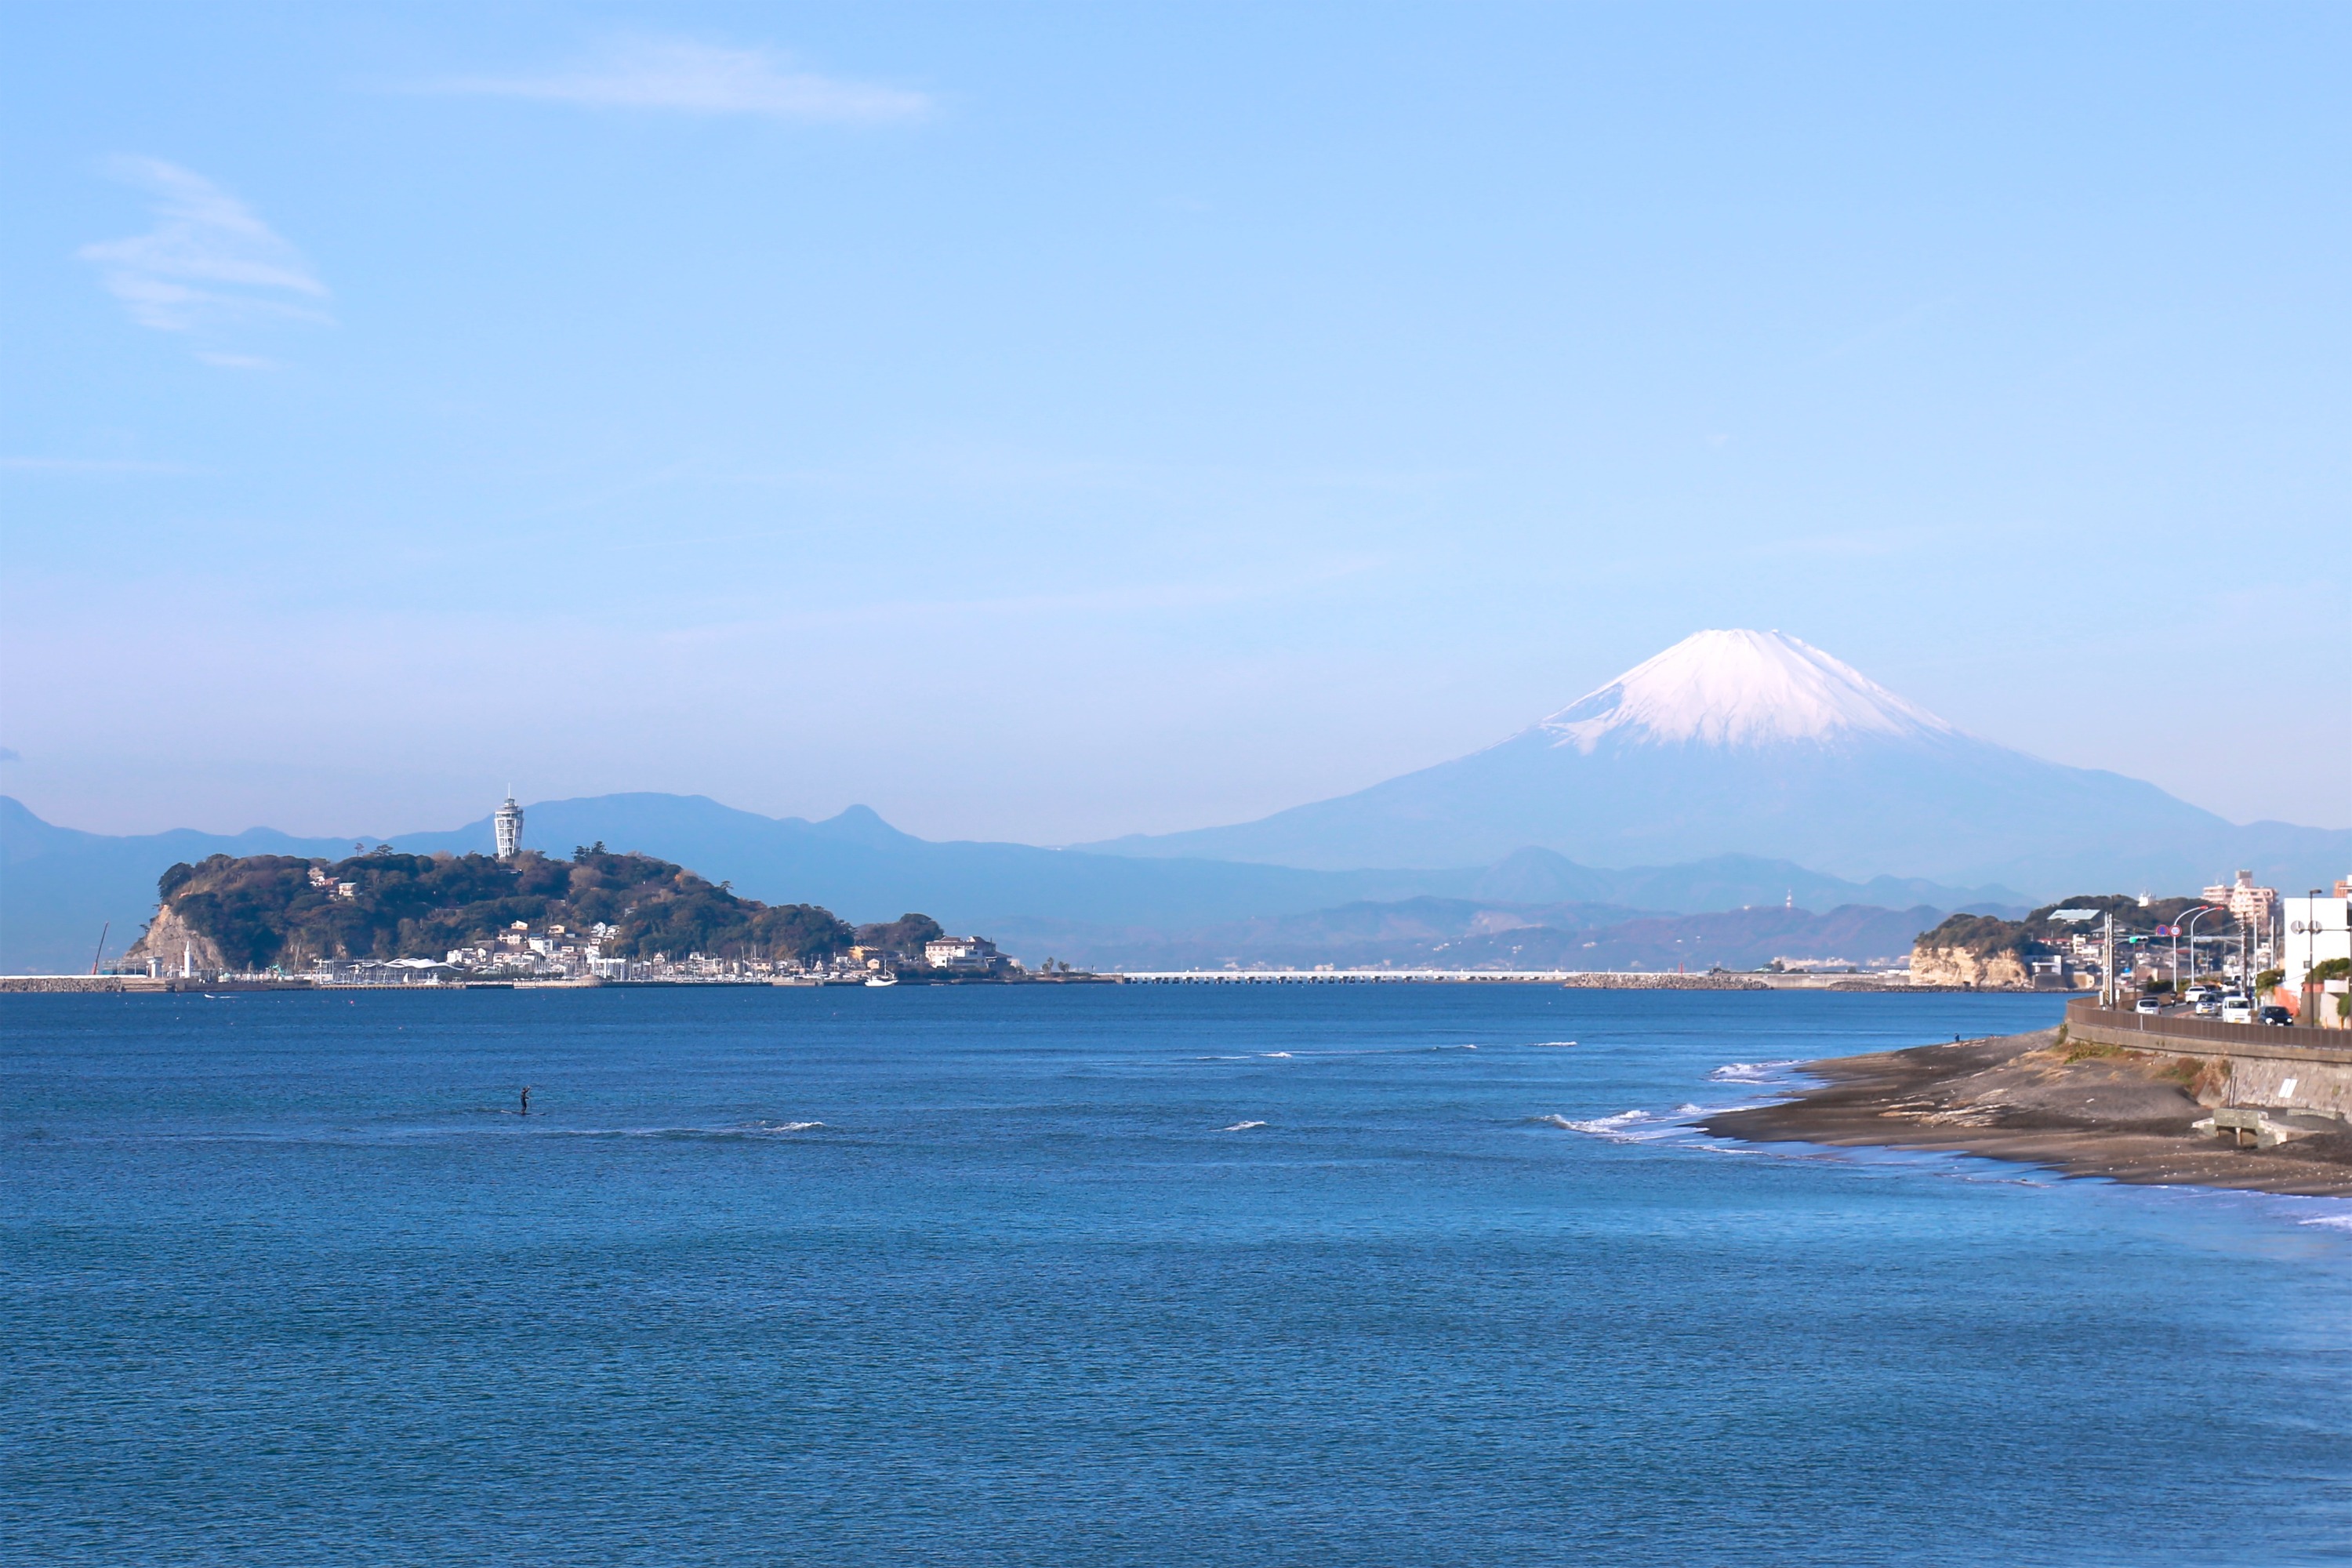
0,2,2352,841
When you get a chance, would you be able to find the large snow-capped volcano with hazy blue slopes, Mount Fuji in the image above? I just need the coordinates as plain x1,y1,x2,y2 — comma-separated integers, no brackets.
1089,630,2352,895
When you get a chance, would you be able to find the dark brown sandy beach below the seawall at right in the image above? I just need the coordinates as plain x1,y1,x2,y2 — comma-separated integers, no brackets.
1700,1029,2352,1196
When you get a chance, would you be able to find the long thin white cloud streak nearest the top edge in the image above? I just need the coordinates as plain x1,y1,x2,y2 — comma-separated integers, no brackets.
426,38,931,125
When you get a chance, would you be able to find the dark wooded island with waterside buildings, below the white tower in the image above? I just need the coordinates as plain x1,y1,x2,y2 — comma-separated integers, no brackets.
125,844,941,973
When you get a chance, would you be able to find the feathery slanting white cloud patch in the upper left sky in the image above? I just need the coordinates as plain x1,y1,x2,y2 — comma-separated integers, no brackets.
78,158,329,345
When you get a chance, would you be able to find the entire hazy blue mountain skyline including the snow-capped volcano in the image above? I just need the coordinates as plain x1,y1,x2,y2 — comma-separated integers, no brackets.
0,633,2352,971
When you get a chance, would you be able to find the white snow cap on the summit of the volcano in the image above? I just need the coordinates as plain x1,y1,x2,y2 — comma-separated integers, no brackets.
1536,633,1959,755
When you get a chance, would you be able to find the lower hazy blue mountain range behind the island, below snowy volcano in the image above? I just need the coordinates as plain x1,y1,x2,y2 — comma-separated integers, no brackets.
0,794,2027,973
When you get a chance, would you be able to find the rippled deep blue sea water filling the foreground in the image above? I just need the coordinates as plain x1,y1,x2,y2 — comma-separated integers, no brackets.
0,985,2352,1566
